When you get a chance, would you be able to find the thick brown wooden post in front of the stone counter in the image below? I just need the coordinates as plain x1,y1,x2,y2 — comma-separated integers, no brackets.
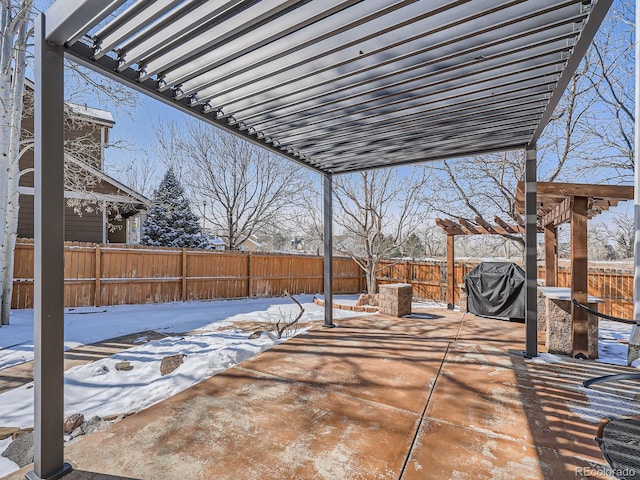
571,197,589,358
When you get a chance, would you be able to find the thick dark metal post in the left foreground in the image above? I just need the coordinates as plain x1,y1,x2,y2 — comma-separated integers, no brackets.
26,15,71,480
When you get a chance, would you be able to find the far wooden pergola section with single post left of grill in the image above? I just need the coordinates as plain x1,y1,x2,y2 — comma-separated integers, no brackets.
436,216,525,309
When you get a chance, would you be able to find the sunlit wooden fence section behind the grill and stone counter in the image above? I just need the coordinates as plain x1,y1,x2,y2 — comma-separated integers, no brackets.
378,261,633,319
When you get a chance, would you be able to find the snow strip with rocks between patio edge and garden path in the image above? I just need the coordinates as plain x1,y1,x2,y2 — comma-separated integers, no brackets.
0,330,279,428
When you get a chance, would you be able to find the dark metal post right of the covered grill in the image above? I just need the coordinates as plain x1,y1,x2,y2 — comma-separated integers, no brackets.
524,145,538,358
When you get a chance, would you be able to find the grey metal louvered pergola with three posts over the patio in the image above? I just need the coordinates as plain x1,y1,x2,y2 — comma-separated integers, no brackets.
33,0,612,480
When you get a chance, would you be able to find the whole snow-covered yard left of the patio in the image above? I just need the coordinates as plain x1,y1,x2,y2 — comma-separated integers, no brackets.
0,295,370,476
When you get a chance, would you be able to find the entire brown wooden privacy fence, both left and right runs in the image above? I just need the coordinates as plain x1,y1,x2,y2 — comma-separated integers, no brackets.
12,240,633,318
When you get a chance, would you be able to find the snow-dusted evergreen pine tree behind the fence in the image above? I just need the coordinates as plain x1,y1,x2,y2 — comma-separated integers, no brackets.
140,169,211,248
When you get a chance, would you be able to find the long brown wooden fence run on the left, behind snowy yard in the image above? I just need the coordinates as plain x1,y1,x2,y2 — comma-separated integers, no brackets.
12,240,364,308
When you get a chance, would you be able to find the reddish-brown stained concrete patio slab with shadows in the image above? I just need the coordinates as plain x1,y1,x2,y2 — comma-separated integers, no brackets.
2,309,640,480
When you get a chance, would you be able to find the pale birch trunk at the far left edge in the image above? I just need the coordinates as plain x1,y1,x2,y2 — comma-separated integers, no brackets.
0,0,33,325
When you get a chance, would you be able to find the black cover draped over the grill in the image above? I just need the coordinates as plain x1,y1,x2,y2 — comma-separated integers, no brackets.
464,262,525,319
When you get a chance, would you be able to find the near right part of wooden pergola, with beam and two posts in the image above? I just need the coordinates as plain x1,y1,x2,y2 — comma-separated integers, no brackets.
516,182,634,356
